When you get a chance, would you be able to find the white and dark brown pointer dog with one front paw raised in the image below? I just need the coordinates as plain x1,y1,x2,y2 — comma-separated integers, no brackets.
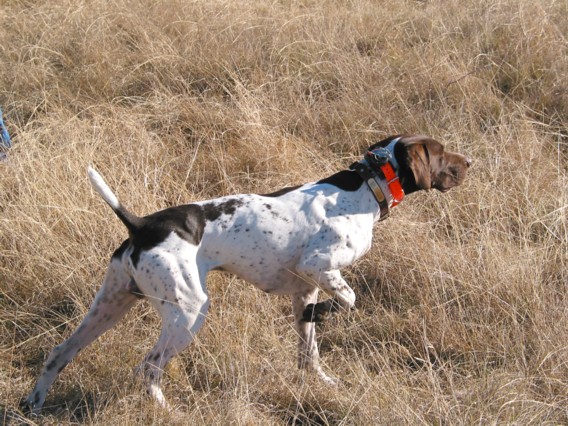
23,135,471,413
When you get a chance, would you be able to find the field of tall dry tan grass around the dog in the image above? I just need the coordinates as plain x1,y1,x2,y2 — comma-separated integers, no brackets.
0,0,568,425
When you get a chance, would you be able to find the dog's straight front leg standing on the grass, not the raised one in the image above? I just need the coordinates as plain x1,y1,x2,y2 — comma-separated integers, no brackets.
292,287,337,384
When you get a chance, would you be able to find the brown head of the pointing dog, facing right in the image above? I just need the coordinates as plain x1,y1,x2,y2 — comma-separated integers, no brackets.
370,135,471,194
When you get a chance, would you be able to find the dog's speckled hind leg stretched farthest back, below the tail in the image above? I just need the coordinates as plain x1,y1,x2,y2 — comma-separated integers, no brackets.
22,258,137,413
